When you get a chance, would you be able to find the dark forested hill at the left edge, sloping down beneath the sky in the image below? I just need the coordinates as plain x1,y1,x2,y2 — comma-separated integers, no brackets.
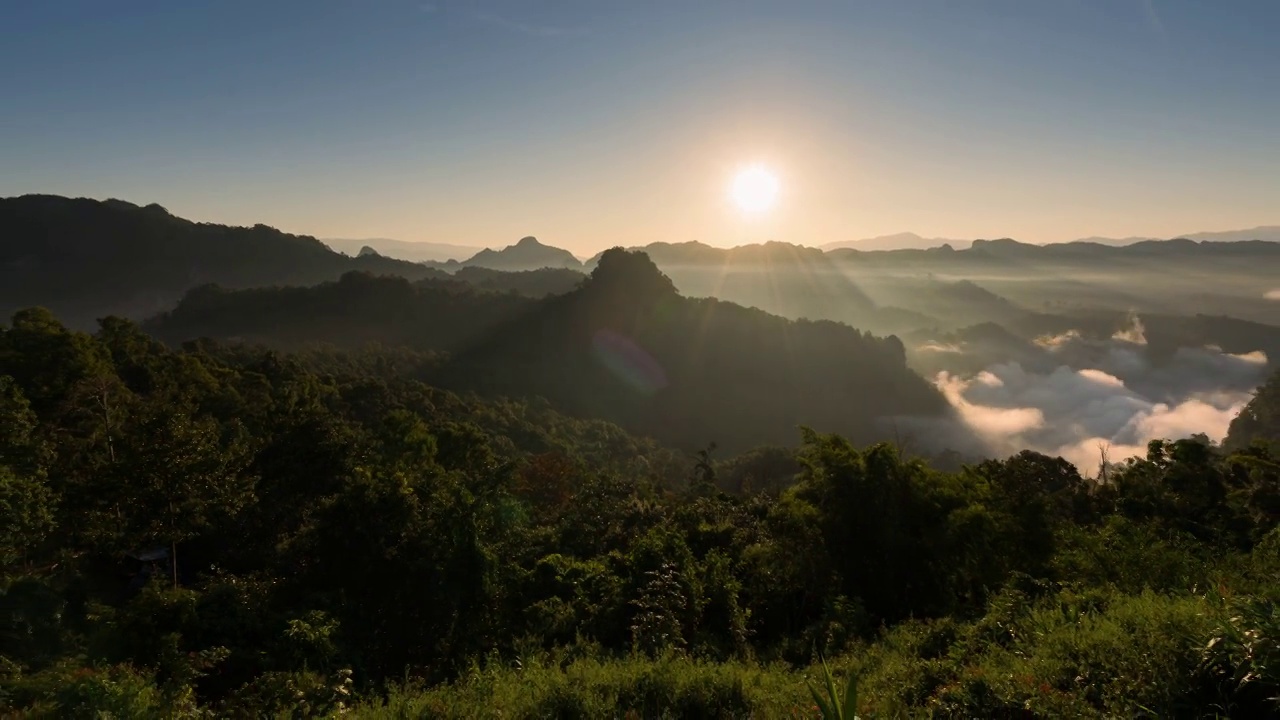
0,195,444,327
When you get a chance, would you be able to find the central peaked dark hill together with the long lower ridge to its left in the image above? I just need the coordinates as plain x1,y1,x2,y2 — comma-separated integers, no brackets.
145,250,947,450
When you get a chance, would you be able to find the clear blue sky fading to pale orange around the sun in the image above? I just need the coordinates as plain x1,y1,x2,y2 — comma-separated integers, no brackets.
0,0,1280,254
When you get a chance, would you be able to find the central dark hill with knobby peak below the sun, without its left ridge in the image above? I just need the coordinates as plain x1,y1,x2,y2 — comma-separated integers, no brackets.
442,249,946,450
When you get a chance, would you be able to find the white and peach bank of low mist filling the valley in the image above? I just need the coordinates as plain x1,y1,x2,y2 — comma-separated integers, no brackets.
911,318,1267,474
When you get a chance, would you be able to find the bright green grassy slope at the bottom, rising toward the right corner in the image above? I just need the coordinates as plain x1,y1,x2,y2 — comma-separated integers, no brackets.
348,593,1275,719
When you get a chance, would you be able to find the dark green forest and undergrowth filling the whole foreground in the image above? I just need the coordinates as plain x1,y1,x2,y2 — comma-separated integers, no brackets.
0,304,1280,719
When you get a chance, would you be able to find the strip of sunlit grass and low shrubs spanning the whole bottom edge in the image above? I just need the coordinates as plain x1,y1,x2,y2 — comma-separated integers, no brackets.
8,579,1280,720
